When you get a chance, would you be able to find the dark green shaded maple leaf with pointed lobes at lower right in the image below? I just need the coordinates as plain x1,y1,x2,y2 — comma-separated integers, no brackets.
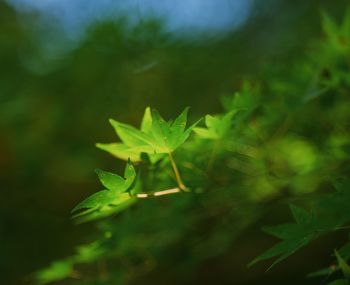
251,179,350,273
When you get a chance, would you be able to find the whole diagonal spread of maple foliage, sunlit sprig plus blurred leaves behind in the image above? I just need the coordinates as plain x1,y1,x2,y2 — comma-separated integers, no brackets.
33,6,350,284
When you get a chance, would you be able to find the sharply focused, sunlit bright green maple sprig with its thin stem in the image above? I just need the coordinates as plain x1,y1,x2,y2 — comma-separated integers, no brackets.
72,107,198,222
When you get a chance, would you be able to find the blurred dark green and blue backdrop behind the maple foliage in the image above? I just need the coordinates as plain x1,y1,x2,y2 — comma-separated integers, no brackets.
0,0,348,285
